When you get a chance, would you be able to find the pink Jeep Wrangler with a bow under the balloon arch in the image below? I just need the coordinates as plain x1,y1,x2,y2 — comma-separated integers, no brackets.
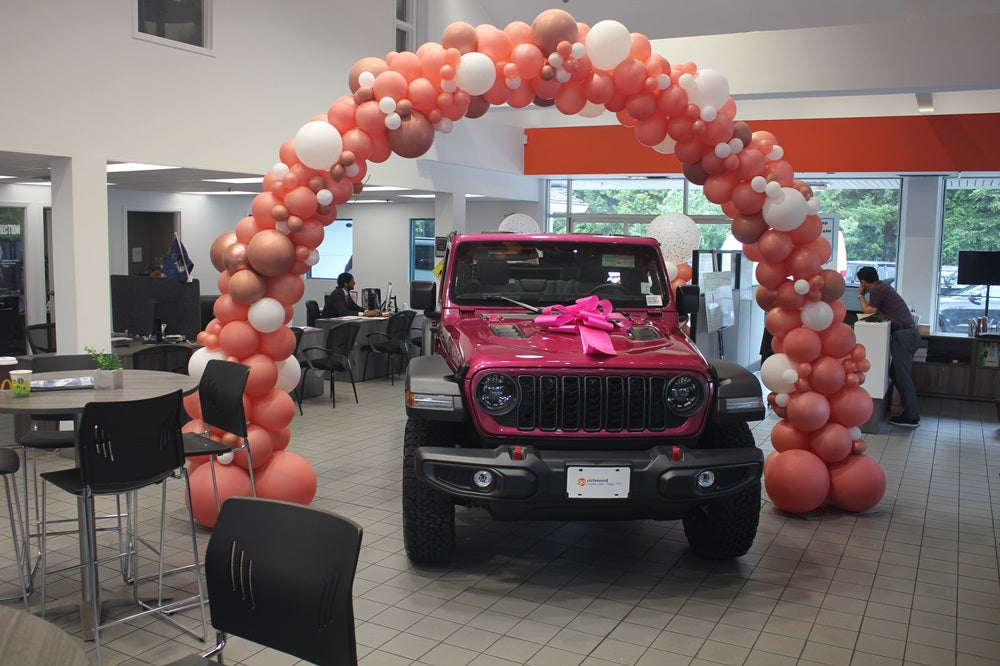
403,233,764,563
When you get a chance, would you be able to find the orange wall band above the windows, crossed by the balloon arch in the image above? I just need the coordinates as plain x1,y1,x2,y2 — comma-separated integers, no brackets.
524,113,1000,175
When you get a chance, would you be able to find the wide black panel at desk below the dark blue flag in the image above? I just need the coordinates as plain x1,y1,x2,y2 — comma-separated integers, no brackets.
111,275,202,340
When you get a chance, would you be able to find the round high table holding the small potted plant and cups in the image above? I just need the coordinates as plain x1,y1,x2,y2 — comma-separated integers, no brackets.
0,370,198,632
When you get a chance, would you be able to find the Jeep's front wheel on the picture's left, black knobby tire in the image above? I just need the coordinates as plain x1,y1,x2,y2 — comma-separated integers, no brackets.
403,419,455,564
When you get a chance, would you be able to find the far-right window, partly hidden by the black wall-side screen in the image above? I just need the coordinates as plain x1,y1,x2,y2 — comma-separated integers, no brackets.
935,178,1000,333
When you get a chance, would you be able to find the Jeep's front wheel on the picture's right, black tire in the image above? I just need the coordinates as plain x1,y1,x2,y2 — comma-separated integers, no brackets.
684,423,760,560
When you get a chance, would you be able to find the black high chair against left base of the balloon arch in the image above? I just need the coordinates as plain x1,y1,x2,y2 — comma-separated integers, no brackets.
184,359,257,510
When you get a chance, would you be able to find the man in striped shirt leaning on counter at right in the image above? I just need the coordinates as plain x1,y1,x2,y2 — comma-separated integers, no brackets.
857,266,920,428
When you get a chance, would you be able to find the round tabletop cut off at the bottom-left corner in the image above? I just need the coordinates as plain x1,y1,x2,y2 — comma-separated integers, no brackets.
0,606,90,666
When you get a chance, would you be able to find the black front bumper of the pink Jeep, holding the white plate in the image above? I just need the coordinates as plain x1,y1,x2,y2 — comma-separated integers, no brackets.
414,445,764,520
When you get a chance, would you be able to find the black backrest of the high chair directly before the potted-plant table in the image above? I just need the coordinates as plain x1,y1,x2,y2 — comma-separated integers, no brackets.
77,390,184,494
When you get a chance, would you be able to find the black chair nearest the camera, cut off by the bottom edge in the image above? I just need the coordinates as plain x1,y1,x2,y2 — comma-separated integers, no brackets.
173,497,362,666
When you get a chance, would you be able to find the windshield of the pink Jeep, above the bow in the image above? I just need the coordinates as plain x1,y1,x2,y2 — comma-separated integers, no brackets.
450,236,669,308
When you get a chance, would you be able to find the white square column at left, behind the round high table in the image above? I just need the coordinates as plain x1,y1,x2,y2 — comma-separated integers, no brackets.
50,156,111,354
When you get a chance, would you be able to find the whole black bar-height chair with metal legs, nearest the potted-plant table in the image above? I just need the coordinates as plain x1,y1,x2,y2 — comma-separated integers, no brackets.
41,390,207,664
